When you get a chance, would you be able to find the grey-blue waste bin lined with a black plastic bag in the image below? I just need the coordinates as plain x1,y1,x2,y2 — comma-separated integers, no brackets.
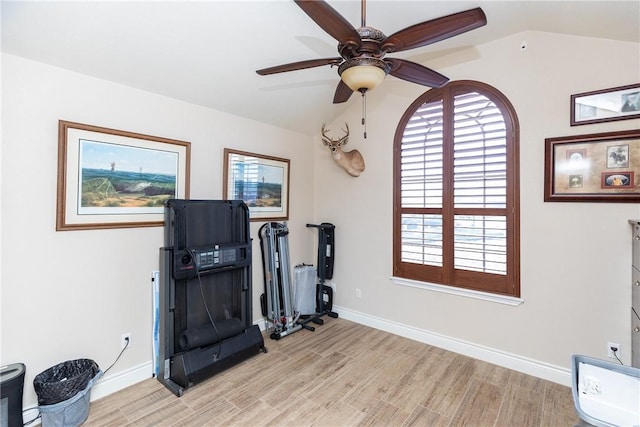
33,359,102,427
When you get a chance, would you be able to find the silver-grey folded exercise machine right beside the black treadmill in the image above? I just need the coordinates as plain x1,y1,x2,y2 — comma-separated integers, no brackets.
258,222,314,340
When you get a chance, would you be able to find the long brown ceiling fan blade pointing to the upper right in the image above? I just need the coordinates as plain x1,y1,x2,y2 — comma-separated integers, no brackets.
381,7,487,52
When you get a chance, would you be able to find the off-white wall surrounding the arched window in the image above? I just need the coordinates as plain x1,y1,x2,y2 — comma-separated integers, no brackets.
314,32,640,369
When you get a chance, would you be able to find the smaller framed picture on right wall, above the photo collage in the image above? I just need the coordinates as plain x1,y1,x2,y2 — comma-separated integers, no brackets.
571,83,640,126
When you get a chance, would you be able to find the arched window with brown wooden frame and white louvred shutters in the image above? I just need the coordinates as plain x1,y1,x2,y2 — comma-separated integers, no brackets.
393,81,520,297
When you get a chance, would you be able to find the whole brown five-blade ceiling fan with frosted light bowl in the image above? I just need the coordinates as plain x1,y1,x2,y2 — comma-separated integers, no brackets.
256,0,487,104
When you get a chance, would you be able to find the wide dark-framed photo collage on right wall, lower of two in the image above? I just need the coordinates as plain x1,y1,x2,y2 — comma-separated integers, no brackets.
544,130,640,203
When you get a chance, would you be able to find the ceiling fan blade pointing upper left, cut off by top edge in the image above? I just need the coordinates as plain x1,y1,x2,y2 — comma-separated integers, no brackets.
295,0,361,48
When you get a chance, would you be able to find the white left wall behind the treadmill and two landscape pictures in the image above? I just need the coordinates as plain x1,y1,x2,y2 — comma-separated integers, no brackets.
0,55,314,405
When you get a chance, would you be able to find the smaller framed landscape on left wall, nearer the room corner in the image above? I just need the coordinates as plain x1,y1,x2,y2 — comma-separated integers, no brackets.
223,148,289,221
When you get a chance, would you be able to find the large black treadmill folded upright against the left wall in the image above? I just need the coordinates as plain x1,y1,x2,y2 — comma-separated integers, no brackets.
157,199,267,396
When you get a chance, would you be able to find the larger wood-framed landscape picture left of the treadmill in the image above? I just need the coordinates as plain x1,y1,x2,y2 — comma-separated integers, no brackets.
56,120,191,231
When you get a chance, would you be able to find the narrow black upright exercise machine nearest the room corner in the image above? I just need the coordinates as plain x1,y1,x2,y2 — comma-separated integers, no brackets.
307,222,338,325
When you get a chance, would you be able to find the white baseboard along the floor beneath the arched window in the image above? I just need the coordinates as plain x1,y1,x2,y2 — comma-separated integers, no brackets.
333,305,571,387
